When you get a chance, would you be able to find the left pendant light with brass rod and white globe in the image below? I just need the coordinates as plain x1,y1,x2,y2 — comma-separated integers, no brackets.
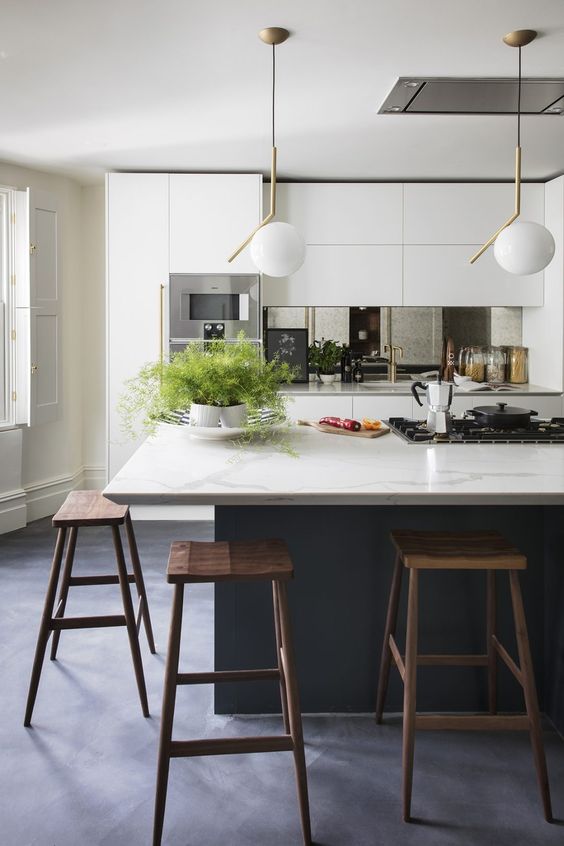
228,26,305,276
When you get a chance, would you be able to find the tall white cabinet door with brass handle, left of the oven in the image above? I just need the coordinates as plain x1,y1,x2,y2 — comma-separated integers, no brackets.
106,173,168,478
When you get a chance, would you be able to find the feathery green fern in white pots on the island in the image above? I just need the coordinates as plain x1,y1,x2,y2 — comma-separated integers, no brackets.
119,334,295,436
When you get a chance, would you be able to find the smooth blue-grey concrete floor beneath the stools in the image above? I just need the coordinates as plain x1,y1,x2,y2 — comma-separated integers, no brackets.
0,520,564,846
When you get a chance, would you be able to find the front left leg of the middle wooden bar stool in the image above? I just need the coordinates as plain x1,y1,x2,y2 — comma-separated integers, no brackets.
153,584,184,846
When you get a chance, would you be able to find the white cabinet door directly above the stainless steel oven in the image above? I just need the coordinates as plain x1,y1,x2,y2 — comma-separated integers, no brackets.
170,173,262,273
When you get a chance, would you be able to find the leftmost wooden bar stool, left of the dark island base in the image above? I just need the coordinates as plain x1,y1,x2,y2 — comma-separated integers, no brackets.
24,491,155,726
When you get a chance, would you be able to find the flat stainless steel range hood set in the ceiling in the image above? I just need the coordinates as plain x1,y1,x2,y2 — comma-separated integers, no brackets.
378,76,564,115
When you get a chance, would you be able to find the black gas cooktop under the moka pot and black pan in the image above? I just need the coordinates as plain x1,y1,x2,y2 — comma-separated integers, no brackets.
384,417,564,444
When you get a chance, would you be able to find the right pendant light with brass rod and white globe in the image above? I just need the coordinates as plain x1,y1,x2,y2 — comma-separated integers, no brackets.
470,29,555,276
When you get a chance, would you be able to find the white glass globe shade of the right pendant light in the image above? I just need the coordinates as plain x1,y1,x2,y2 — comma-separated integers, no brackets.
494,220,554,276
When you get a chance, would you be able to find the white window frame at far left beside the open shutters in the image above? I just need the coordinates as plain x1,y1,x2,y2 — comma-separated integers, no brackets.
0,185,16,431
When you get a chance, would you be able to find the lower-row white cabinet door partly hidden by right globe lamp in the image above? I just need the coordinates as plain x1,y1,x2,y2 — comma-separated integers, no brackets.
403,243,543,306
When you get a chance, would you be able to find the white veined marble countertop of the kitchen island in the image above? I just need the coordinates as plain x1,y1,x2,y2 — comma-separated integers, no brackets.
104,424,564,505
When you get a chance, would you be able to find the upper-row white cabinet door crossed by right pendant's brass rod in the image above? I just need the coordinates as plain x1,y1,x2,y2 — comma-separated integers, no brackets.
404,183,544,244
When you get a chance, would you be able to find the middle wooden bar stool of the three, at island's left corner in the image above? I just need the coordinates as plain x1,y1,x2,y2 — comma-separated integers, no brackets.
153,540,311,846
